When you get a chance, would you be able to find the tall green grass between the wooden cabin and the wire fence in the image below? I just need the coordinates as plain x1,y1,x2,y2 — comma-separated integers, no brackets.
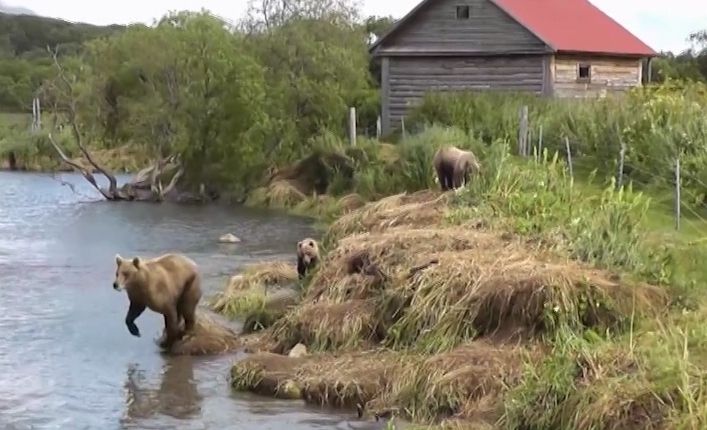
408,82,707,203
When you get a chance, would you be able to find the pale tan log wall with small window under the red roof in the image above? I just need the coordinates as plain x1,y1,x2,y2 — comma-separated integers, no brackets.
553,55,642,97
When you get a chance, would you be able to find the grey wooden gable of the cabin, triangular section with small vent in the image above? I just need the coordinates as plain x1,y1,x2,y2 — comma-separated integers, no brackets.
378,0,547,55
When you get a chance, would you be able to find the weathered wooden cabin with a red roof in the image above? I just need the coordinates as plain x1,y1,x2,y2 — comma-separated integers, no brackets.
370,0,657,134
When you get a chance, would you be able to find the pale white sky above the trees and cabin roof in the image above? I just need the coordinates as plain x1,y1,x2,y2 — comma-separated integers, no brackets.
3,0,707,52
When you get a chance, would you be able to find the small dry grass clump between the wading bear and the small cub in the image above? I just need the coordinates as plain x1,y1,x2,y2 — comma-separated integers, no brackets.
211,261,297,316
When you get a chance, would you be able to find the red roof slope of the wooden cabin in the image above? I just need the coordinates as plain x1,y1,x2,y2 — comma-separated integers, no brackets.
491,0,657,56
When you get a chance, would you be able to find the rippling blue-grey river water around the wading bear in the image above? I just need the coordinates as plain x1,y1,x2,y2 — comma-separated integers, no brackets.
0,172,381,430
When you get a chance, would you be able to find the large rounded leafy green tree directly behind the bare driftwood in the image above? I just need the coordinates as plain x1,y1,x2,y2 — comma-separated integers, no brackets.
40,12,274,200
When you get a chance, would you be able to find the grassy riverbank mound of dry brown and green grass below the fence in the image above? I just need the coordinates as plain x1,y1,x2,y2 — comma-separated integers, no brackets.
216,129,707,429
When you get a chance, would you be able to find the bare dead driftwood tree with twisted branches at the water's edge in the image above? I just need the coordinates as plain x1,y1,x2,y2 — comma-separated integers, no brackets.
48,45,188,202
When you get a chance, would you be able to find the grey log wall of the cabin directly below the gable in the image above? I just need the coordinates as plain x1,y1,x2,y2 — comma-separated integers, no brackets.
382,55,549,133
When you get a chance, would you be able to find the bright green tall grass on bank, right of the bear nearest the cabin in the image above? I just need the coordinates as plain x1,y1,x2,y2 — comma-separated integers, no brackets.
448,136,656,281
